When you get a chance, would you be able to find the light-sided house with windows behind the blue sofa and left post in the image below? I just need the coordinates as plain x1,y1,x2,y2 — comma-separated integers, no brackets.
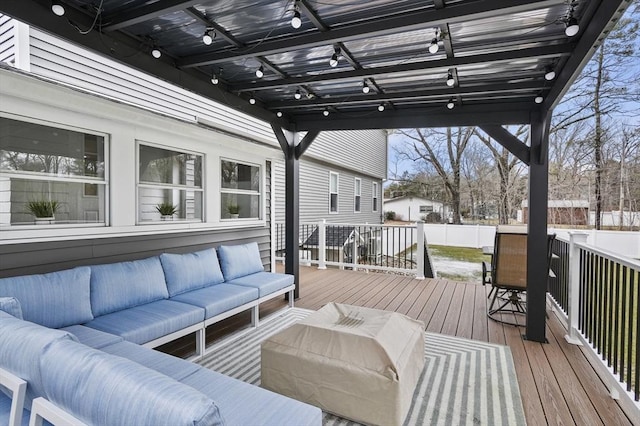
0,15,386,276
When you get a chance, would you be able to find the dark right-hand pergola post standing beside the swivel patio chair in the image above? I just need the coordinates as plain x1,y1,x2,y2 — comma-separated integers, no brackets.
525,112,551,342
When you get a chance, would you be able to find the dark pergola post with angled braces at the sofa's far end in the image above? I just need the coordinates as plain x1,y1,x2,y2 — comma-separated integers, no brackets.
271,123,319,299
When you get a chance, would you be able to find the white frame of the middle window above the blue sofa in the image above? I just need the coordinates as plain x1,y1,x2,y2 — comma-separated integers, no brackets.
135,140,206,225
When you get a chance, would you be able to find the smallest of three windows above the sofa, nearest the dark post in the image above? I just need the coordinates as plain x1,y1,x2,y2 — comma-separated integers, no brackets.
220,160,262,219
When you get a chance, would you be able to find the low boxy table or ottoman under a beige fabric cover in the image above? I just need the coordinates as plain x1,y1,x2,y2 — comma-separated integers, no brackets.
261,303,424,426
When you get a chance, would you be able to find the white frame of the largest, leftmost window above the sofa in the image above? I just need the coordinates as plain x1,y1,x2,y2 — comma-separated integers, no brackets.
0,113,111,231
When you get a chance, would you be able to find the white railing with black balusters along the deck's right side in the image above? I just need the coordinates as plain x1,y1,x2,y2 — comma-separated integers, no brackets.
549,232,640,418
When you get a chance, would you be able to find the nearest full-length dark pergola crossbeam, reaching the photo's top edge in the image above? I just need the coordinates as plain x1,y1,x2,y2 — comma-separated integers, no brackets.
179,0,564,67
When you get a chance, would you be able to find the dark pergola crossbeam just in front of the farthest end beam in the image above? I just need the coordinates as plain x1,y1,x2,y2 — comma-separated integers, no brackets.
266,80,544,110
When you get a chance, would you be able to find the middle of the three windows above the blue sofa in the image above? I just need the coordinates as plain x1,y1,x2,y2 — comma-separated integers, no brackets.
138,144,203,223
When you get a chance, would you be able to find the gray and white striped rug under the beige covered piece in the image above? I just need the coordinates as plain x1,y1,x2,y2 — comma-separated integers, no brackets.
199,308,526,426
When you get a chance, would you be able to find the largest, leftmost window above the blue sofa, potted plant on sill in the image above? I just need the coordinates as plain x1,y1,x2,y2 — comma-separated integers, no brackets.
0,113,107,226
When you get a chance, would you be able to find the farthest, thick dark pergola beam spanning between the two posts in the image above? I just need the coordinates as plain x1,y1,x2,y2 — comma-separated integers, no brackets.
289,102,531,131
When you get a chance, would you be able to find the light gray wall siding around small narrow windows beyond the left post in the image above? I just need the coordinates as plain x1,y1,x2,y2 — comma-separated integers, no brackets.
273,157,382,223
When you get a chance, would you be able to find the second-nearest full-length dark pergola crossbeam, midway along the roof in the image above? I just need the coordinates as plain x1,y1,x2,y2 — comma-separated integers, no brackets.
230,43,575,92
